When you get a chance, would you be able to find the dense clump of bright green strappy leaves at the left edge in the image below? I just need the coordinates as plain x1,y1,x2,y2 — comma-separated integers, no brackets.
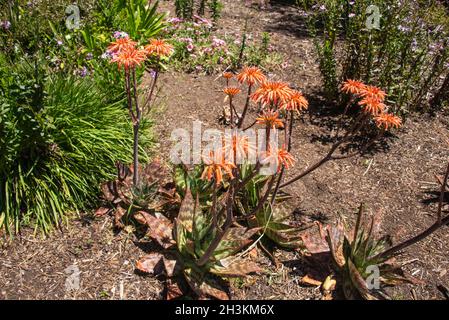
0,61,149,232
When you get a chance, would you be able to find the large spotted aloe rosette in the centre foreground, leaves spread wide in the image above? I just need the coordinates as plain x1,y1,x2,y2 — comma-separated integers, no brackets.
136,189,262,299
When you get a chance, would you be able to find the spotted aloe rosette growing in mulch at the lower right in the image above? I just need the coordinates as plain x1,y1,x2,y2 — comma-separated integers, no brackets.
303,205,417,300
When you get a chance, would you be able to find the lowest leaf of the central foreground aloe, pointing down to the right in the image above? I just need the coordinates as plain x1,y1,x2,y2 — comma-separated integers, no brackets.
184,268,229,300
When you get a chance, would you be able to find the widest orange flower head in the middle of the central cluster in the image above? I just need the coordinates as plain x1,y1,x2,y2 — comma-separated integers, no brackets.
251,81,293,105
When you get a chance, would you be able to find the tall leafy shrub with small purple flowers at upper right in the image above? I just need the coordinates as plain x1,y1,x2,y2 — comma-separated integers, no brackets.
298,0,449,116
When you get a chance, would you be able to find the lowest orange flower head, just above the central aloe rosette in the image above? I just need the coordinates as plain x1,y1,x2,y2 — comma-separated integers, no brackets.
201,151,236,186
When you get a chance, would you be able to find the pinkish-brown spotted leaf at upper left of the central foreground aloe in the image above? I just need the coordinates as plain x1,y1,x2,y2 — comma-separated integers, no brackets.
134,211,175,249
